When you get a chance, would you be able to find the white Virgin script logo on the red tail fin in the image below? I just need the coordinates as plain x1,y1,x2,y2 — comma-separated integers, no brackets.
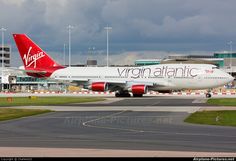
23,47,45,68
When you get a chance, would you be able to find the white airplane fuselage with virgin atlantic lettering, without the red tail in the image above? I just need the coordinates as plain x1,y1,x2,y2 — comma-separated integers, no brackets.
51,64,233,90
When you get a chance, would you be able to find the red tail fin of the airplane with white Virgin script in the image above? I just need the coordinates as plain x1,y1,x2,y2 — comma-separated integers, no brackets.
13,34,63,77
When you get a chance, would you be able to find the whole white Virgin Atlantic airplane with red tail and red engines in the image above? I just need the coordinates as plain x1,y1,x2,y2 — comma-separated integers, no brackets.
13,34,234,97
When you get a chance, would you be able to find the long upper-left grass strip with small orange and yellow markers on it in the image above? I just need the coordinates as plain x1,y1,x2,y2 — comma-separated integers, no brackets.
0,96,105,107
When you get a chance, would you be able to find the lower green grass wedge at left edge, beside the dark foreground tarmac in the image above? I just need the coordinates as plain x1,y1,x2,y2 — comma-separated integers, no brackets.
0,108,51,121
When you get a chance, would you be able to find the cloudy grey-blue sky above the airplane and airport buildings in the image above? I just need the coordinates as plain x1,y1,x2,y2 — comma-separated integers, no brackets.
0,0,236,65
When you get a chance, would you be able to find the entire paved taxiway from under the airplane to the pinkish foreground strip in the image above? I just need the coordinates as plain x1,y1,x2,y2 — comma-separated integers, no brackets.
0,97,236,156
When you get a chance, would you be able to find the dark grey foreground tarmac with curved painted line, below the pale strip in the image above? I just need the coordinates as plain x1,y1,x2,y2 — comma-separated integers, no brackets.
0,111,236,152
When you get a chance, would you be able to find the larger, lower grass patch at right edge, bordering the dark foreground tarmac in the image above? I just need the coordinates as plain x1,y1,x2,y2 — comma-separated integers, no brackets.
184,111,236,126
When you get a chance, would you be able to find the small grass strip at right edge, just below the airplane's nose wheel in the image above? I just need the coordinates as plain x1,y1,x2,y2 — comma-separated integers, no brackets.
207,98,236,106
